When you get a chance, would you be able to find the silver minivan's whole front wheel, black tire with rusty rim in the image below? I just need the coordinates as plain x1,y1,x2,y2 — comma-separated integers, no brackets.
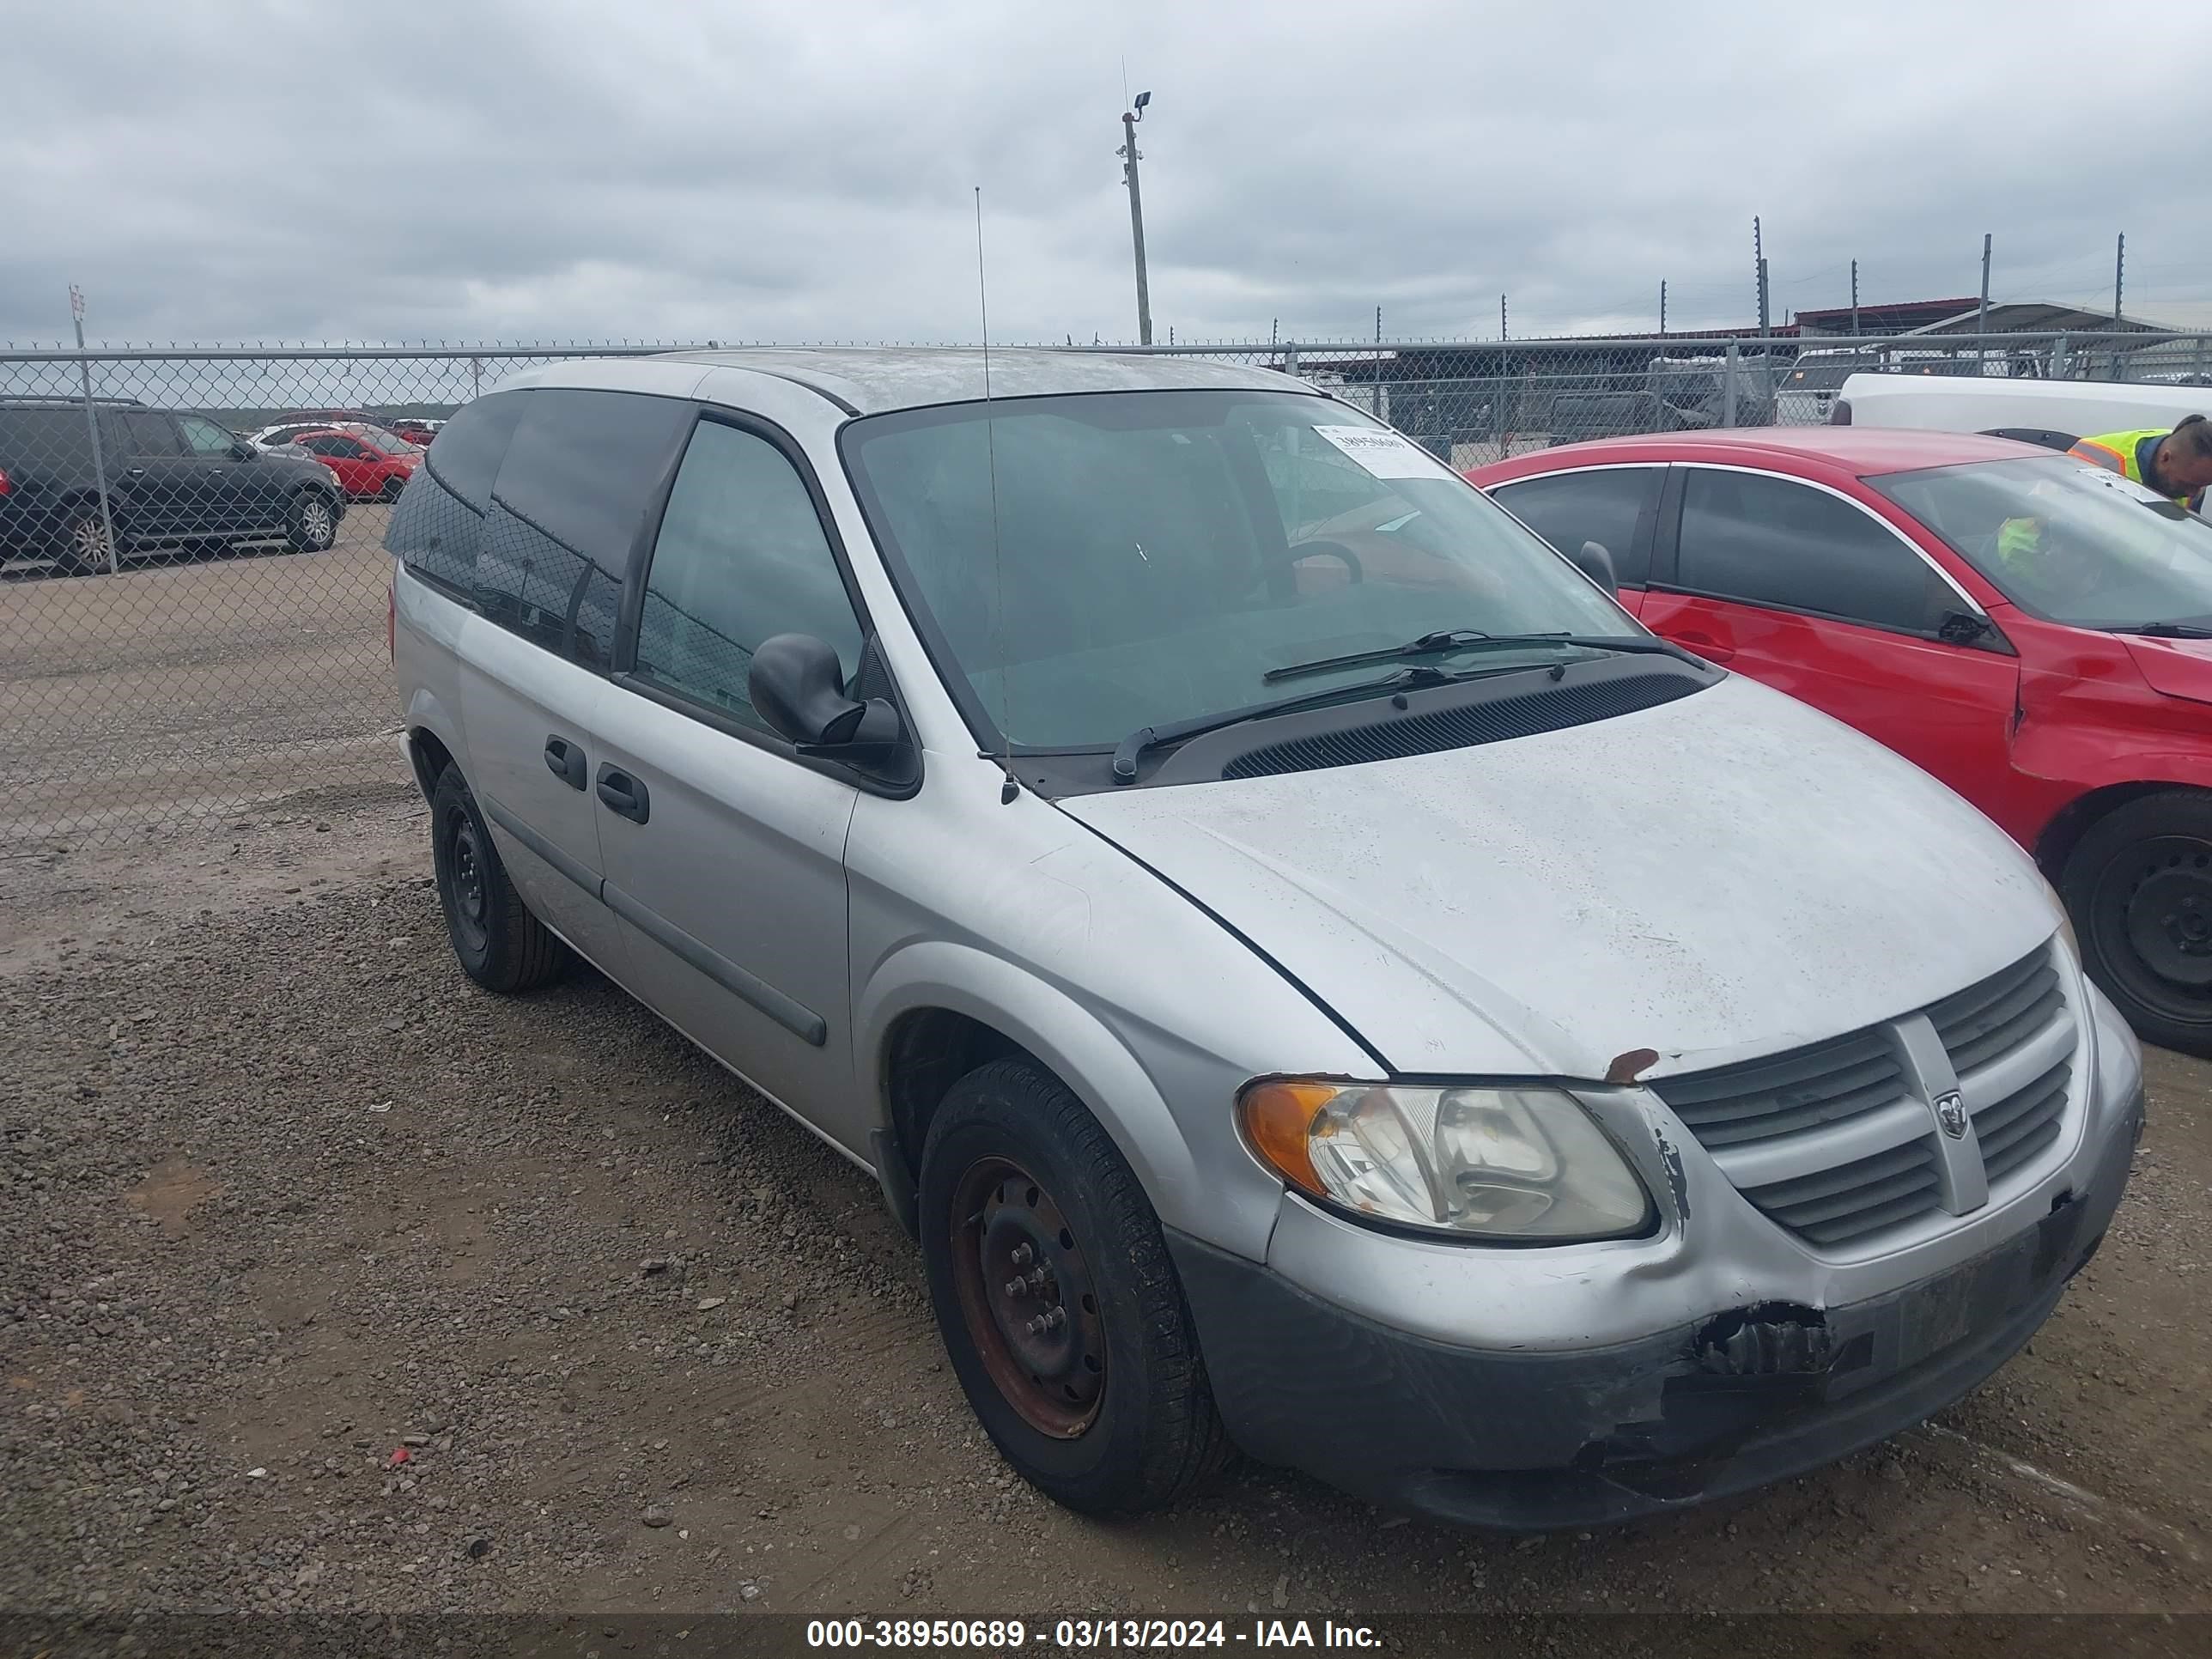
921,1060,1228,1516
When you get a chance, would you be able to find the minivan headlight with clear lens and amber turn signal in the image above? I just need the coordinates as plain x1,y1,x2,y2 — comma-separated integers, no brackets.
1237,1079,1652,1243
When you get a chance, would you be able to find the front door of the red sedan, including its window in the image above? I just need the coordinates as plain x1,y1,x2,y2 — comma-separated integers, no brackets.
1644,467,2020,821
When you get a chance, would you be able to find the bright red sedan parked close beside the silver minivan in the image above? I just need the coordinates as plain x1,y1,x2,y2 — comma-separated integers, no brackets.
1468,427,2212,1055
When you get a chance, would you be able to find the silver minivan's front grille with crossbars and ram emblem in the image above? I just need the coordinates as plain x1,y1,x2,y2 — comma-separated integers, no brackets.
1655,947,2077,1248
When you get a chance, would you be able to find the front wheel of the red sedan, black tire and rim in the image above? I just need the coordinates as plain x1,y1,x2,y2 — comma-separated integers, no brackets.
2059,790,2212,1055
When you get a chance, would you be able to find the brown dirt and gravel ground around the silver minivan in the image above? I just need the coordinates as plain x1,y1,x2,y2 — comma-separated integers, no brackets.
0,528,2212,1652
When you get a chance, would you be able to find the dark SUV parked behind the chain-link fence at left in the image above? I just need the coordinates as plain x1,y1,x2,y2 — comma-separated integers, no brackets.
0,398,345,575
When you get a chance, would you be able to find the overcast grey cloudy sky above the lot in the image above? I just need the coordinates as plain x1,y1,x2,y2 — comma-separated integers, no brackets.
0,0,2212,343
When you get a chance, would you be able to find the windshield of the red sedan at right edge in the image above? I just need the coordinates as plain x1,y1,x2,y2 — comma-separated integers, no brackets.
1867,456,2212,630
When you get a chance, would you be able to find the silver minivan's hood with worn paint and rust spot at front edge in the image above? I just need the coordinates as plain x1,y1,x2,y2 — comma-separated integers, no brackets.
1061,677,2059,1079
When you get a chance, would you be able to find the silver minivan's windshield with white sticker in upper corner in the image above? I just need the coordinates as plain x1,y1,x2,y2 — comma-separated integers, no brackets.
842,392,1648,750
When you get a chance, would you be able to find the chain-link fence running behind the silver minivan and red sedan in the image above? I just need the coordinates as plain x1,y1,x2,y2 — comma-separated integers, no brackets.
0,331,2212,849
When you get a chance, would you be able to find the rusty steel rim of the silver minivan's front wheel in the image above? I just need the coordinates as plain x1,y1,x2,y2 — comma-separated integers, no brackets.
951,1157,1106,1440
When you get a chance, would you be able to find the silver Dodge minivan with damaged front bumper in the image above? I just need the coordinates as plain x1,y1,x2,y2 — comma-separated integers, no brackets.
387,349,2143,1528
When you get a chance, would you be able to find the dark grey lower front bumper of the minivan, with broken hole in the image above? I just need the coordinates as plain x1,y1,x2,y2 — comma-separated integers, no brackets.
1168,1088,2143,1531
